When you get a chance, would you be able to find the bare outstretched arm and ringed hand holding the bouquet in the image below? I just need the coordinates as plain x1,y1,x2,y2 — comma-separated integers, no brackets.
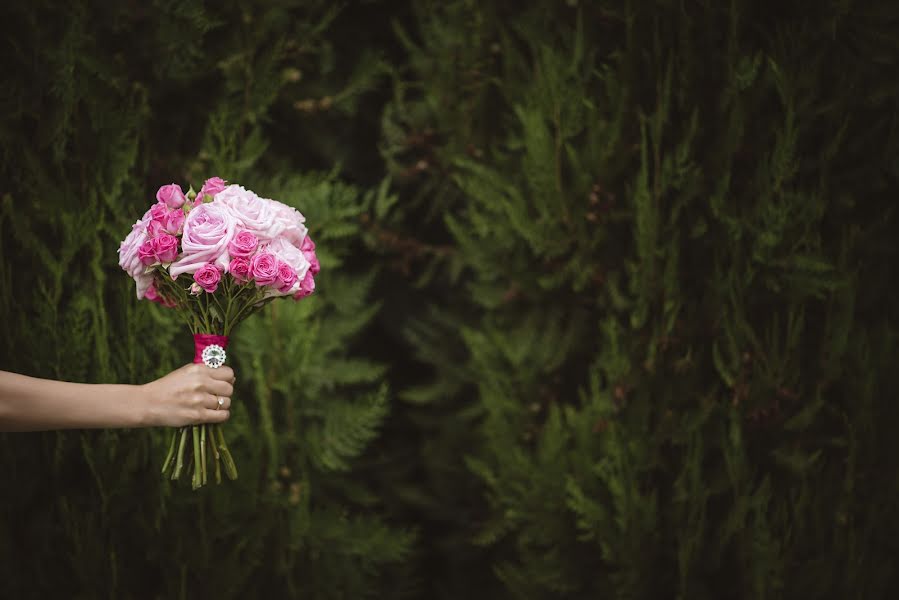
0,364,234,431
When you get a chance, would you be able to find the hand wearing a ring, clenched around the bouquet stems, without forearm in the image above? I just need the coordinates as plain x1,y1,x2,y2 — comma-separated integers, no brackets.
141,364,234,427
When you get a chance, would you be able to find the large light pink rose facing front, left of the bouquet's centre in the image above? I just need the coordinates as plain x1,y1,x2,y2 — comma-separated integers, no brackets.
169,202,237,277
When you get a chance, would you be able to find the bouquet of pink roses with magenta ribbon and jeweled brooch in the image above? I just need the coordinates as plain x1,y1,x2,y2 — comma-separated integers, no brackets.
119,177,319,489
